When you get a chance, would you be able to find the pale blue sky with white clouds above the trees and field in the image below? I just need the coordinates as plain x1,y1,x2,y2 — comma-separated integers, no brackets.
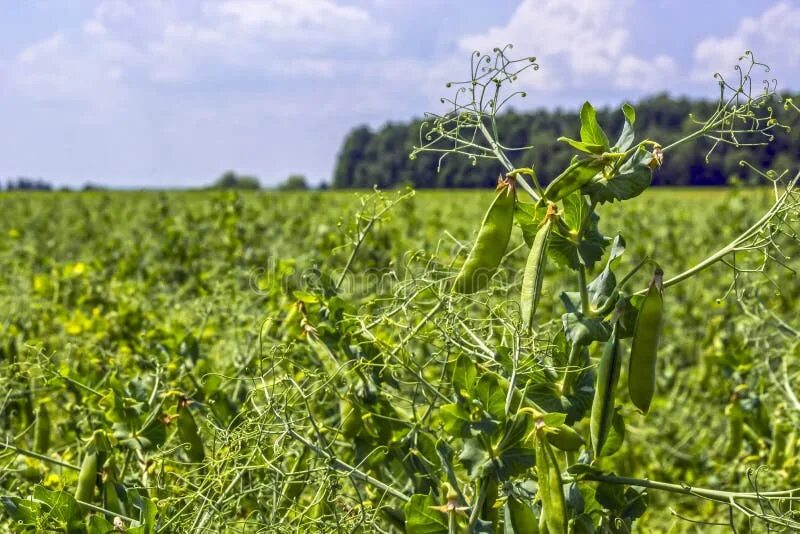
0,0,800,188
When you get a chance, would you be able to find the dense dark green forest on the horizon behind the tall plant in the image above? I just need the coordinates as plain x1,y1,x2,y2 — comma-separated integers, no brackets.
332,94,800,189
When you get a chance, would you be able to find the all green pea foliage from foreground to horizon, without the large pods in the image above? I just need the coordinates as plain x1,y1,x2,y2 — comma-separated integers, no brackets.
0,51,800,533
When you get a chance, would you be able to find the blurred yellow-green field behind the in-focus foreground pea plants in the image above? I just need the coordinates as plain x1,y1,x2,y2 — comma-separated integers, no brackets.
0,188,800,532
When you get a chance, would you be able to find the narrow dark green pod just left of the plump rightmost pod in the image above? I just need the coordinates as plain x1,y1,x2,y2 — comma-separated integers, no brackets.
590,323,622,457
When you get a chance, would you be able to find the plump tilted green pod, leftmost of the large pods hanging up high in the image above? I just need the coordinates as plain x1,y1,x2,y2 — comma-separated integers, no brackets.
453,177,516,293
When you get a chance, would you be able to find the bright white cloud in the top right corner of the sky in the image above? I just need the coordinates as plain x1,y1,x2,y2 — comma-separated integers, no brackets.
692,2,800,84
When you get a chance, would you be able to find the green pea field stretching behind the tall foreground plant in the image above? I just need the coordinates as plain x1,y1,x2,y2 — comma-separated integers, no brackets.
0,189,800,532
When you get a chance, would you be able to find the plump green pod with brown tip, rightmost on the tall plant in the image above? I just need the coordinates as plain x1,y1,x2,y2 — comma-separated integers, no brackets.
628,268,664,413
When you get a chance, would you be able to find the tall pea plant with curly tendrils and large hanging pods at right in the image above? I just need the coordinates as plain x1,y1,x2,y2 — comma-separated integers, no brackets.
272,47,800,533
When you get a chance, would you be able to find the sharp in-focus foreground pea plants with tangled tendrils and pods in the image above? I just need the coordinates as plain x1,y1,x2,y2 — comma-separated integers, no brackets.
0,46,800,534
